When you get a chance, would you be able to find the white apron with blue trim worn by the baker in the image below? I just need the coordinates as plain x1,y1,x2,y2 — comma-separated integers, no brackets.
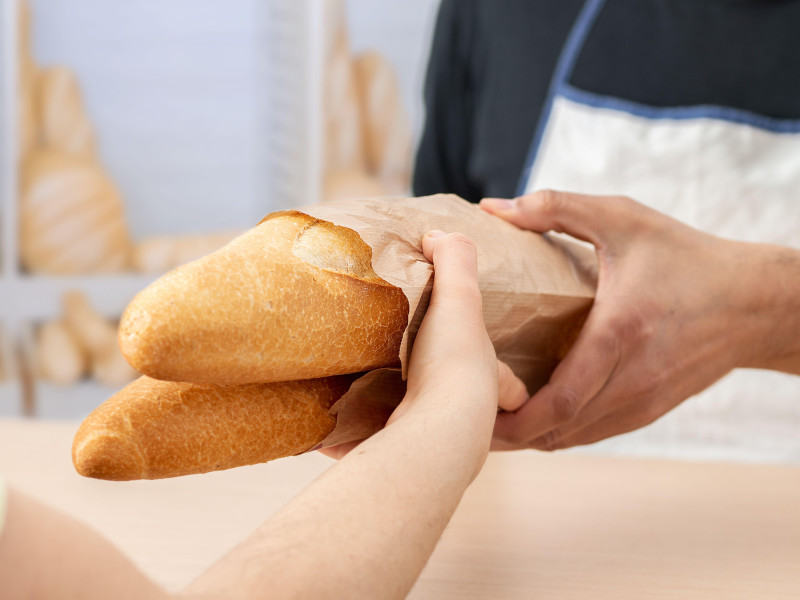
519,0,800,463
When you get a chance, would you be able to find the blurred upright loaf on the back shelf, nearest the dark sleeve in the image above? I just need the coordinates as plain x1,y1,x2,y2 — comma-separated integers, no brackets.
354,52,412,194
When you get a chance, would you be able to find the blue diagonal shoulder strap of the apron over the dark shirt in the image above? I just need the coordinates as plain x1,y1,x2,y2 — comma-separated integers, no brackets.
517,0,605,196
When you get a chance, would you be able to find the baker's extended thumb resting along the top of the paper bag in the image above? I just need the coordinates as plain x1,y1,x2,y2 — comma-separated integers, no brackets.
481,190,636,248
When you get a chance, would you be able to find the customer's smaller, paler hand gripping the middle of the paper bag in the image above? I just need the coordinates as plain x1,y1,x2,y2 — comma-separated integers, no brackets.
321,231,528,459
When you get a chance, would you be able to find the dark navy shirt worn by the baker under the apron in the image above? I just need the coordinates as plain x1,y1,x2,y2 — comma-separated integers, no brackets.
414,0,800,201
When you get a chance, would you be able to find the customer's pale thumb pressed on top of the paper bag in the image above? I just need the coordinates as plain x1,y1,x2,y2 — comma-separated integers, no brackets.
422,231,482,322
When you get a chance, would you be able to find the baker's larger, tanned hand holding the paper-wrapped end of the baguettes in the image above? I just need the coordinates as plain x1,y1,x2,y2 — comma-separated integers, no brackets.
481,191,796,450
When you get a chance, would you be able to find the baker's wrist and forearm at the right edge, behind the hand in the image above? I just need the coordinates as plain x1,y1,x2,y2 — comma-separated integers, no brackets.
743,244,800,375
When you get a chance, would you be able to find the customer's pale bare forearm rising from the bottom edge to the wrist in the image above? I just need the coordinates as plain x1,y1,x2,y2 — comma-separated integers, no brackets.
187,399,496,600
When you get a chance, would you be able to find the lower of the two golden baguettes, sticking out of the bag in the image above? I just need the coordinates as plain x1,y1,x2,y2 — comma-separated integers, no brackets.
72,376,353,481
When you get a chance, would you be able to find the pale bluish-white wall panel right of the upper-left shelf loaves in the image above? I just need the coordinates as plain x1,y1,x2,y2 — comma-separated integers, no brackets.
32,0,262,236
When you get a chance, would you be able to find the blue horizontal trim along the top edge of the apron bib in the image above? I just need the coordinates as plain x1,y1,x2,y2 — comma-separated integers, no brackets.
559,84,800,133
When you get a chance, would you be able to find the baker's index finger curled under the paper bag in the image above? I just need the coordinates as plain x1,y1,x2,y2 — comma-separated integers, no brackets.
494,323,619,447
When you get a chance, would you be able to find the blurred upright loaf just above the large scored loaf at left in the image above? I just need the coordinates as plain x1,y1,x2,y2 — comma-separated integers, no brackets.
36,67,95,156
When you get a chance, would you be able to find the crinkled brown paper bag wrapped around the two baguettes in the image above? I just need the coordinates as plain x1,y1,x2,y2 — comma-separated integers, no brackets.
290,195,597,446
